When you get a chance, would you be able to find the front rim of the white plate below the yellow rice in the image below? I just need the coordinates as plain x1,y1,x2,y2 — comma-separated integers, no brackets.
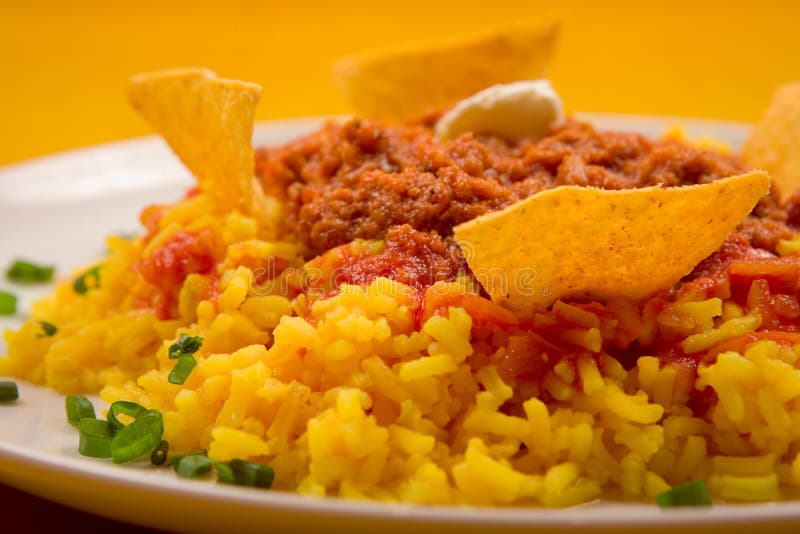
6,436,800,528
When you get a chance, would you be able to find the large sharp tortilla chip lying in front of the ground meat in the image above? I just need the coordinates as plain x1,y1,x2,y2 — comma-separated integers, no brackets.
454,171,769,316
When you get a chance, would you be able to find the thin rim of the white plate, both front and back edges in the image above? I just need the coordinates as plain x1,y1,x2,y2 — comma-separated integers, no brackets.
6,113,800,528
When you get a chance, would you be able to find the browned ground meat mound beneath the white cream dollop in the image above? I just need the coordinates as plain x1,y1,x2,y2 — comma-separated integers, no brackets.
256,120,800,284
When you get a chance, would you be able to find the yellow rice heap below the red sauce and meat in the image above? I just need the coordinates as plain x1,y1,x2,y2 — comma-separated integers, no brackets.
0,191,800,507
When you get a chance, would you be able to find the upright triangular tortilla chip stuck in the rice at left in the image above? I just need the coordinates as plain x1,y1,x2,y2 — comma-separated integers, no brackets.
128,69,261,213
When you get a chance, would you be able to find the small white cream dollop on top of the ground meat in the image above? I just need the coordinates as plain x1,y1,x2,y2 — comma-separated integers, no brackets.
434,80,564,141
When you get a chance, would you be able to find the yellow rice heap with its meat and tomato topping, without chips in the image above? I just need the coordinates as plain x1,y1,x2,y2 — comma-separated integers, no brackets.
0,120,800,507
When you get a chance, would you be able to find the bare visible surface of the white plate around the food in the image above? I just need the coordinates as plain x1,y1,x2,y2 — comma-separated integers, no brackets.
0,115,800,533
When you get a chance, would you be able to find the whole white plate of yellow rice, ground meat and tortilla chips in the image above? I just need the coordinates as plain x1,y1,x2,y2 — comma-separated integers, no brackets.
0,18,800,532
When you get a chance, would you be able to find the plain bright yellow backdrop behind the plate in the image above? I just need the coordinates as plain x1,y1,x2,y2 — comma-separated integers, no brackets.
0,0,800,164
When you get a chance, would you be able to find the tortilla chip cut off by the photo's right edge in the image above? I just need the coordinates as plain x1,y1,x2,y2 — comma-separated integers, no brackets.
742,81,800,201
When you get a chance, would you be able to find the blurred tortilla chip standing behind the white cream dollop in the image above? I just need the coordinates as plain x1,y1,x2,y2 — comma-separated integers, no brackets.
333,20,560,120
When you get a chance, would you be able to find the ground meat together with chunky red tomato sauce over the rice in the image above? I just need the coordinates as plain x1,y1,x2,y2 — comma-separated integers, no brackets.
248,115,800,405
